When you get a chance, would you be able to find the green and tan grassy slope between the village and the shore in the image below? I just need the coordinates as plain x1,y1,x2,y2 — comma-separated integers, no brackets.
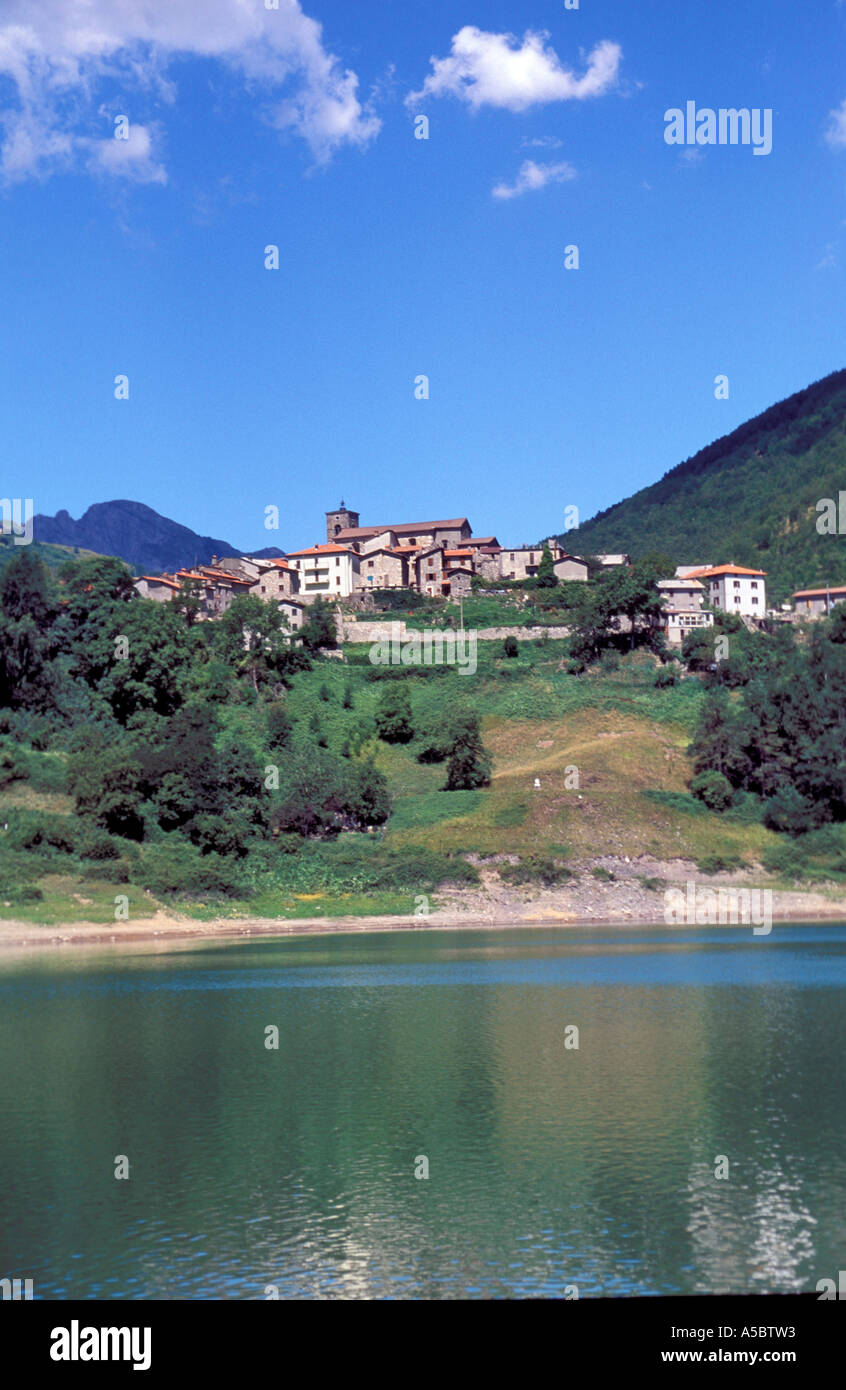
0,641,778,923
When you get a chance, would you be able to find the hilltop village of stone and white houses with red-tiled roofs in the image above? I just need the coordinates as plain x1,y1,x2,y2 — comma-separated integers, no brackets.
135,502,846,646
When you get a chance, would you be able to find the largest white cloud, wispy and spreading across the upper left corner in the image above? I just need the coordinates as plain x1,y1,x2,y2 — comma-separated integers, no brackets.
0,0,381,182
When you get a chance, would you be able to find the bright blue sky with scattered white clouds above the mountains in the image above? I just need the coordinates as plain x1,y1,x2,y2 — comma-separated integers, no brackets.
0,0,846,549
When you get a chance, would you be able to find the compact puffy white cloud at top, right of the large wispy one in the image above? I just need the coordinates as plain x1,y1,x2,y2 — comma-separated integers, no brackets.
407,25,622,111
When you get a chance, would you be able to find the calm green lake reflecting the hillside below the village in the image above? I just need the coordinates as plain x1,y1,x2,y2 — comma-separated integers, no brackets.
0,924,846,1300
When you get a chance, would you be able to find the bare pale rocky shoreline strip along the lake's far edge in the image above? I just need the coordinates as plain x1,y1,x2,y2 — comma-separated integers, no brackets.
0,856,846,947
